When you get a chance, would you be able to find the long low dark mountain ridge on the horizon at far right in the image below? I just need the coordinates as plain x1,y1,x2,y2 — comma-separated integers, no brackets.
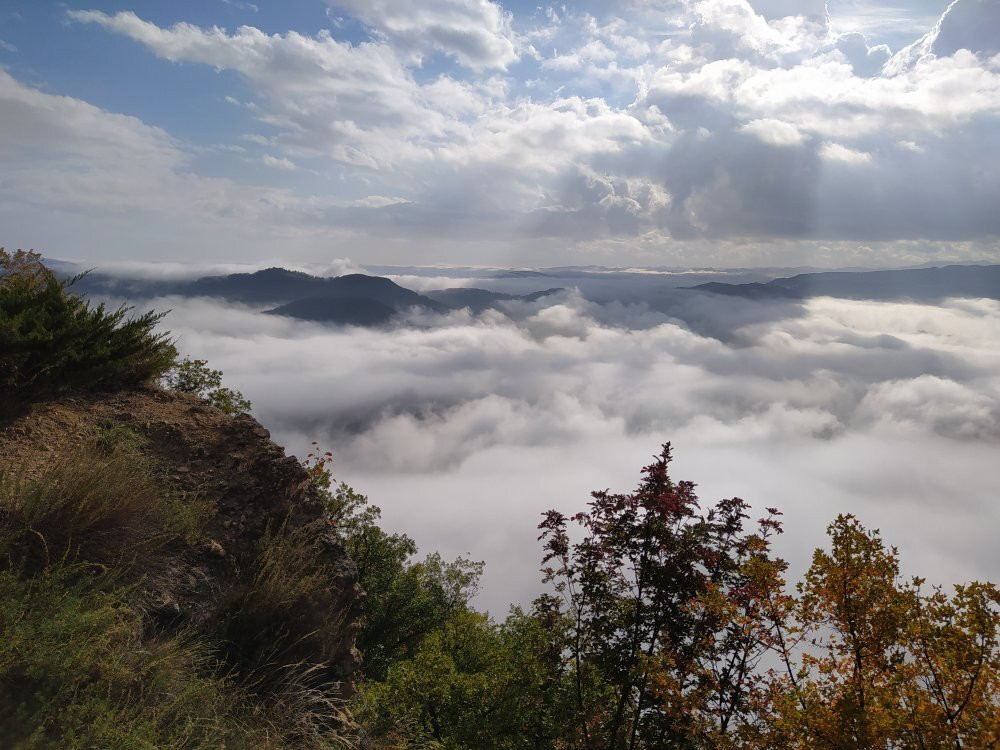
690,265,1000,302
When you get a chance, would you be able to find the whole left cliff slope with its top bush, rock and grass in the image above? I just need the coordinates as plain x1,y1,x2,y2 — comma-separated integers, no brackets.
0,253,360,750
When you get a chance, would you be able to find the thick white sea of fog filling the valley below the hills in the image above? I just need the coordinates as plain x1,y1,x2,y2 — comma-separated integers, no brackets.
146,291,1000,612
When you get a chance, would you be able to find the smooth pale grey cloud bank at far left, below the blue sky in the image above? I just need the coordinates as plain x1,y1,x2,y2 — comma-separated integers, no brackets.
0,70,352,261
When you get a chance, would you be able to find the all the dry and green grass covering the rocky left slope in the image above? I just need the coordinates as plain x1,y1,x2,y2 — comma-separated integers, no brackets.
0,432,360,750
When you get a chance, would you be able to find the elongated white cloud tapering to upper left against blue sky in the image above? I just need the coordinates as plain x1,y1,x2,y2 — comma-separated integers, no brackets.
70,11,472,167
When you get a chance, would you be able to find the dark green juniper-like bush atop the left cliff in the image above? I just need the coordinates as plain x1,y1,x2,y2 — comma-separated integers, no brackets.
0,253,177,418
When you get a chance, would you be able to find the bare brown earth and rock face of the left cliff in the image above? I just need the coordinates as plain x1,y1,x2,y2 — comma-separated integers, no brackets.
0,388,363,698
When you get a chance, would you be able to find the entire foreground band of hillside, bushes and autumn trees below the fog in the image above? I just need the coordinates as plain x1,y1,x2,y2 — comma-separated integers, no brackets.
0,252,1000,750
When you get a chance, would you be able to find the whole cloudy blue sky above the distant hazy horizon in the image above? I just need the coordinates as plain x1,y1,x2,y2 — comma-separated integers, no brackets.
0,0,1000,267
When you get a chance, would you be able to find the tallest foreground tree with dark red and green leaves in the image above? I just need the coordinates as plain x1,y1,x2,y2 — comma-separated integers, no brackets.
539,443,784,750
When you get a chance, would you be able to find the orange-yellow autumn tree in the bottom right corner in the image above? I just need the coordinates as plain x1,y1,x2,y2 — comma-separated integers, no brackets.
763,515,1000,750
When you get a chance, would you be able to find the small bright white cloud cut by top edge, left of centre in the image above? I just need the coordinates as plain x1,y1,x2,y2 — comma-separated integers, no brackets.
327,0,518,70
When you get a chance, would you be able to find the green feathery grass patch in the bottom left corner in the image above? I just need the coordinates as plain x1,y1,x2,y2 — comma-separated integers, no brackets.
0,564,248,750
